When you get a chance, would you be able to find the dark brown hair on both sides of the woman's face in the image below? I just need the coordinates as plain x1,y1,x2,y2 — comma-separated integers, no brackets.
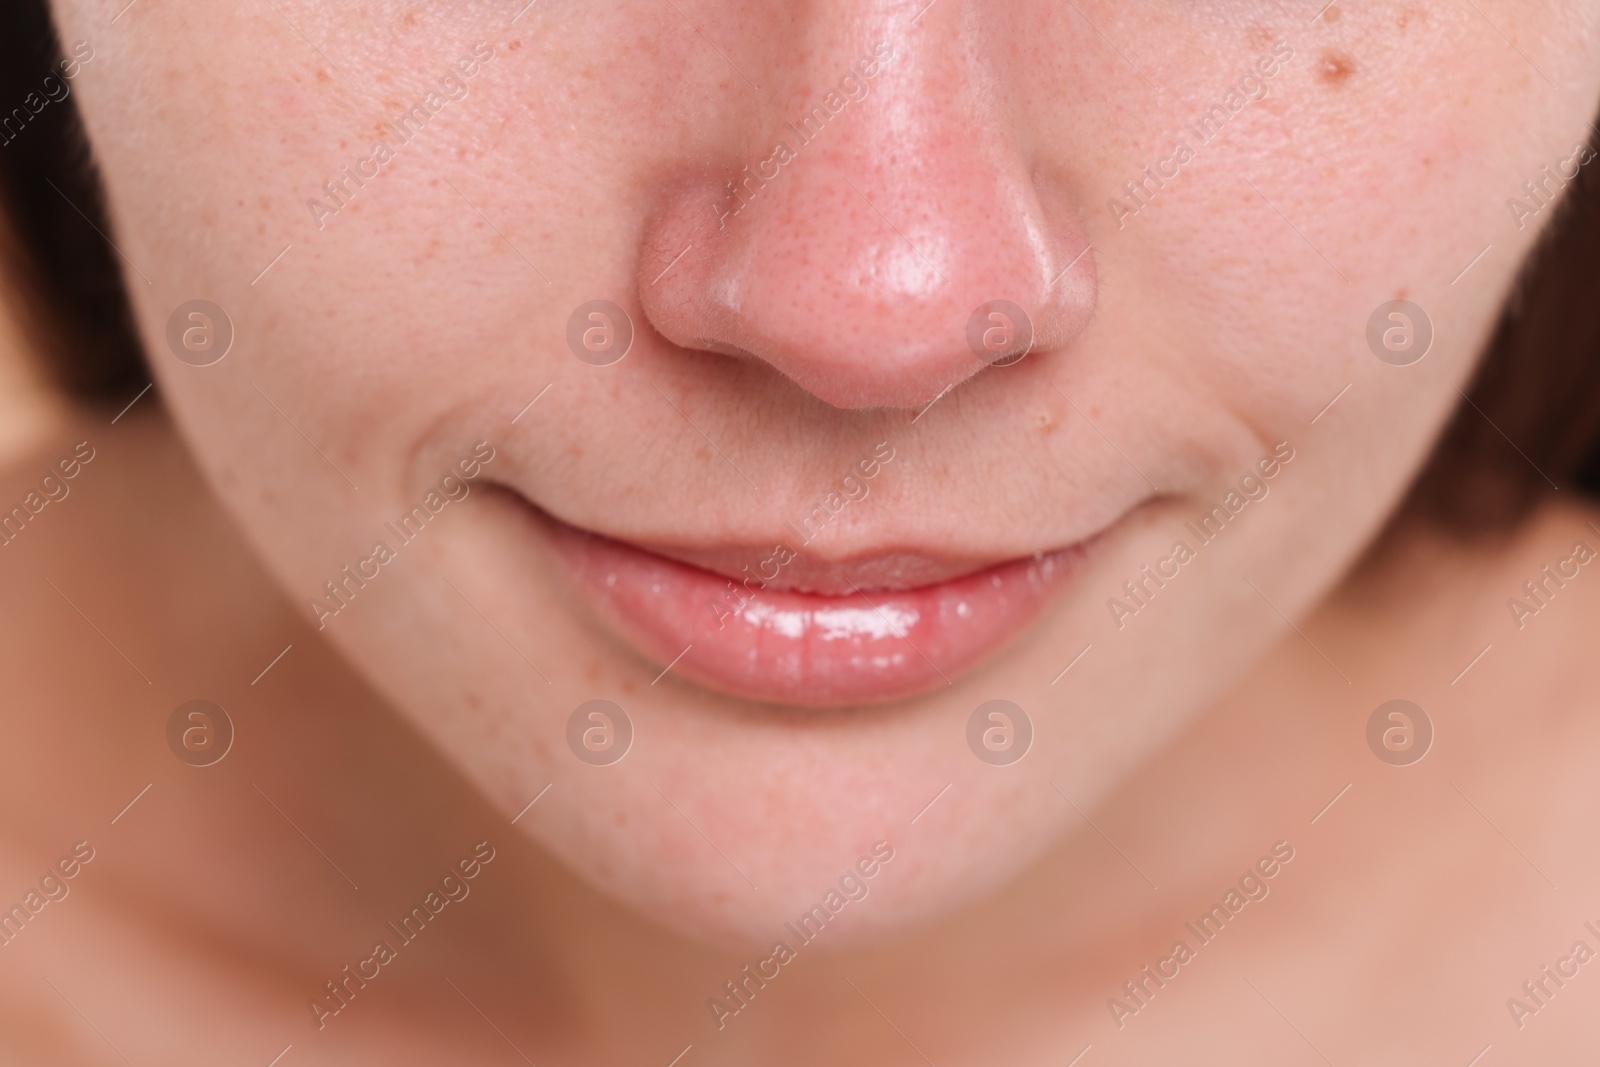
0,0,1600,536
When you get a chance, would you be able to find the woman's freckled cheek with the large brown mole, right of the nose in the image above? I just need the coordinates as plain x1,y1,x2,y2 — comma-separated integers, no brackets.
1088,5,1594,466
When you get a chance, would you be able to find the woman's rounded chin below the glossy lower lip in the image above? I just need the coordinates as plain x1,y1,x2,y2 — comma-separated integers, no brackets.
510,686,1066,955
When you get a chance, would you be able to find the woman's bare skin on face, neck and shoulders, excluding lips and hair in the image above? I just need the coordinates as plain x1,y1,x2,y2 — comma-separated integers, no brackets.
0,0,1600,1067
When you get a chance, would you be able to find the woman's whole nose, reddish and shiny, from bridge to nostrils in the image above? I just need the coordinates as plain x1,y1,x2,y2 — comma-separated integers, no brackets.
638,21,1096,408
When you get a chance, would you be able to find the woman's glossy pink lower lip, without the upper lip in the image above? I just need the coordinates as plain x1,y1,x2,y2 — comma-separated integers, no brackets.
541,511,1085,707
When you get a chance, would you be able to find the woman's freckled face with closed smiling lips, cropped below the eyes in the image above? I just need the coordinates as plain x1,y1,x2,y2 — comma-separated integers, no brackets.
58,0,1600,944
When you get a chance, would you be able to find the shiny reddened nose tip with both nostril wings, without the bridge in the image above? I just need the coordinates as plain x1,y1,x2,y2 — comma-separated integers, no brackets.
640,150,1096,408
